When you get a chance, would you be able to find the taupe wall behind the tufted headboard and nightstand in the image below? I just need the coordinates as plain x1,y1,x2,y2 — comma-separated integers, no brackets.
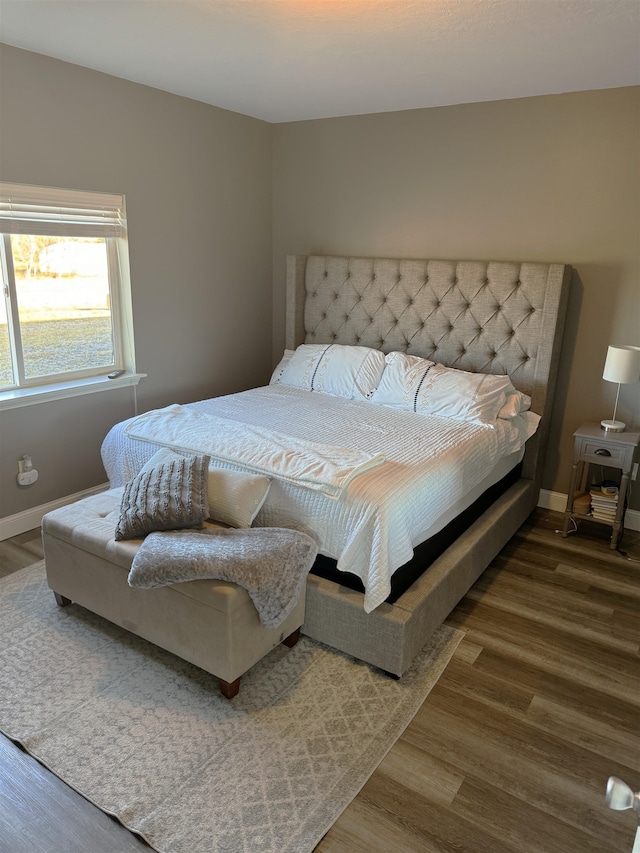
273,87,640,508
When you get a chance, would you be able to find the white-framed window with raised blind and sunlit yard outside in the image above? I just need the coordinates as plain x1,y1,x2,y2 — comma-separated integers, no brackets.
0,183,135,397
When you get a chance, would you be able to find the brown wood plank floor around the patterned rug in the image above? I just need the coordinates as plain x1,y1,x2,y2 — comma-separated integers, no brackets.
0,510,640,853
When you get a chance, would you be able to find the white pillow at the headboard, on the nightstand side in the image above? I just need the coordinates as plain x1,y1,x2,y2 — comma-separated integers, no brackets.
371,352,515,424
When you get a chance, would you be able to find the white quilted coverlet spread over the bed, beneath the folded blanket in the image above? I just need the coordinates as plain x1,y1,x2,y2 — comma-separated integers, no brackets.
102,385,539,612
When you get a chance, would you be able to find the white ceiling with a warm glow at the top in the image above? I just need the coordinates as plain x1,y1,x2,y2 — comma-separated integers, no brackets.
0,0,640,122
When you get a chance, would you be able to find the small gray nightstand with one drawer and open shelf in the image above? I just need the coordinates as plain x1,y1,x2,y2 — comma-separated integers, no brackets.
562,423,640,549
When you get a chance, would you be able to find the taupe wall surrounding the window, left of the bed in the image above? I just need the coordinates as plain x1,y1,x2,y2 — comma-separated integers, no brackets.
0,45,272,518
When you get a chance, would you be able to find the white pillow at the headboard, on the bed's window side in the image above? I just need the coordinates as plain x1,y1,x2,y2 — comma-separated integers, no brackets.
276,344,385,400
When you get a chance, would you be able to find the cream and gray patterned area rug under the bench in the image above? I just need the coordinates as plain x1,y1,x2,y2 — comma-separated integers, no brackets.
0,563,463,853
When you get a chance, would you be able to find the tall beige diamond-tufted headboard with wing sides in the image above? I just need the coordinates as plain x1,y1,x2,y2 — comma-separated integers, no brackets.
285,255,571,479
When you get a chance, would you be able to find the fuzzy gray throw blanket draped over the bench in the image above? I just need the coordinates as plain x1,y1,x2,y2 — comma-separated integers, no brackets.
128,527,318,628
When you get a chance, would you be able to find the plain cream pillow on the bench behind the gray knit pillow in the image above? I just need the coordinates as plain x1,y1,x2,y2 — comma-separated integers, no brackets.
140,447,271,528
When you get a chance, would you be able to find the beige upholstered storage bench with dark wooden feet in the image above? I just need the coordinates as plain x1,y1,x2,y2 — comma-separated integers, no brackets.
42,488,305,698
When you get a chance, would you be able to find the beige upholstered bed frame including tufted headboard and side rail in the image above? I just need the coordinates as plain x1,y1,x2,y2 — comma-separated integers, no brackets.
285,255,571,677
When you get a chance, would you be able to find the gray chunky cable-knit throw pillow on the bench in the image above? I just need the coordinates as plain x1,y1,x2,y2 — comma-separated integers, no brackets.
115,451,209,540
